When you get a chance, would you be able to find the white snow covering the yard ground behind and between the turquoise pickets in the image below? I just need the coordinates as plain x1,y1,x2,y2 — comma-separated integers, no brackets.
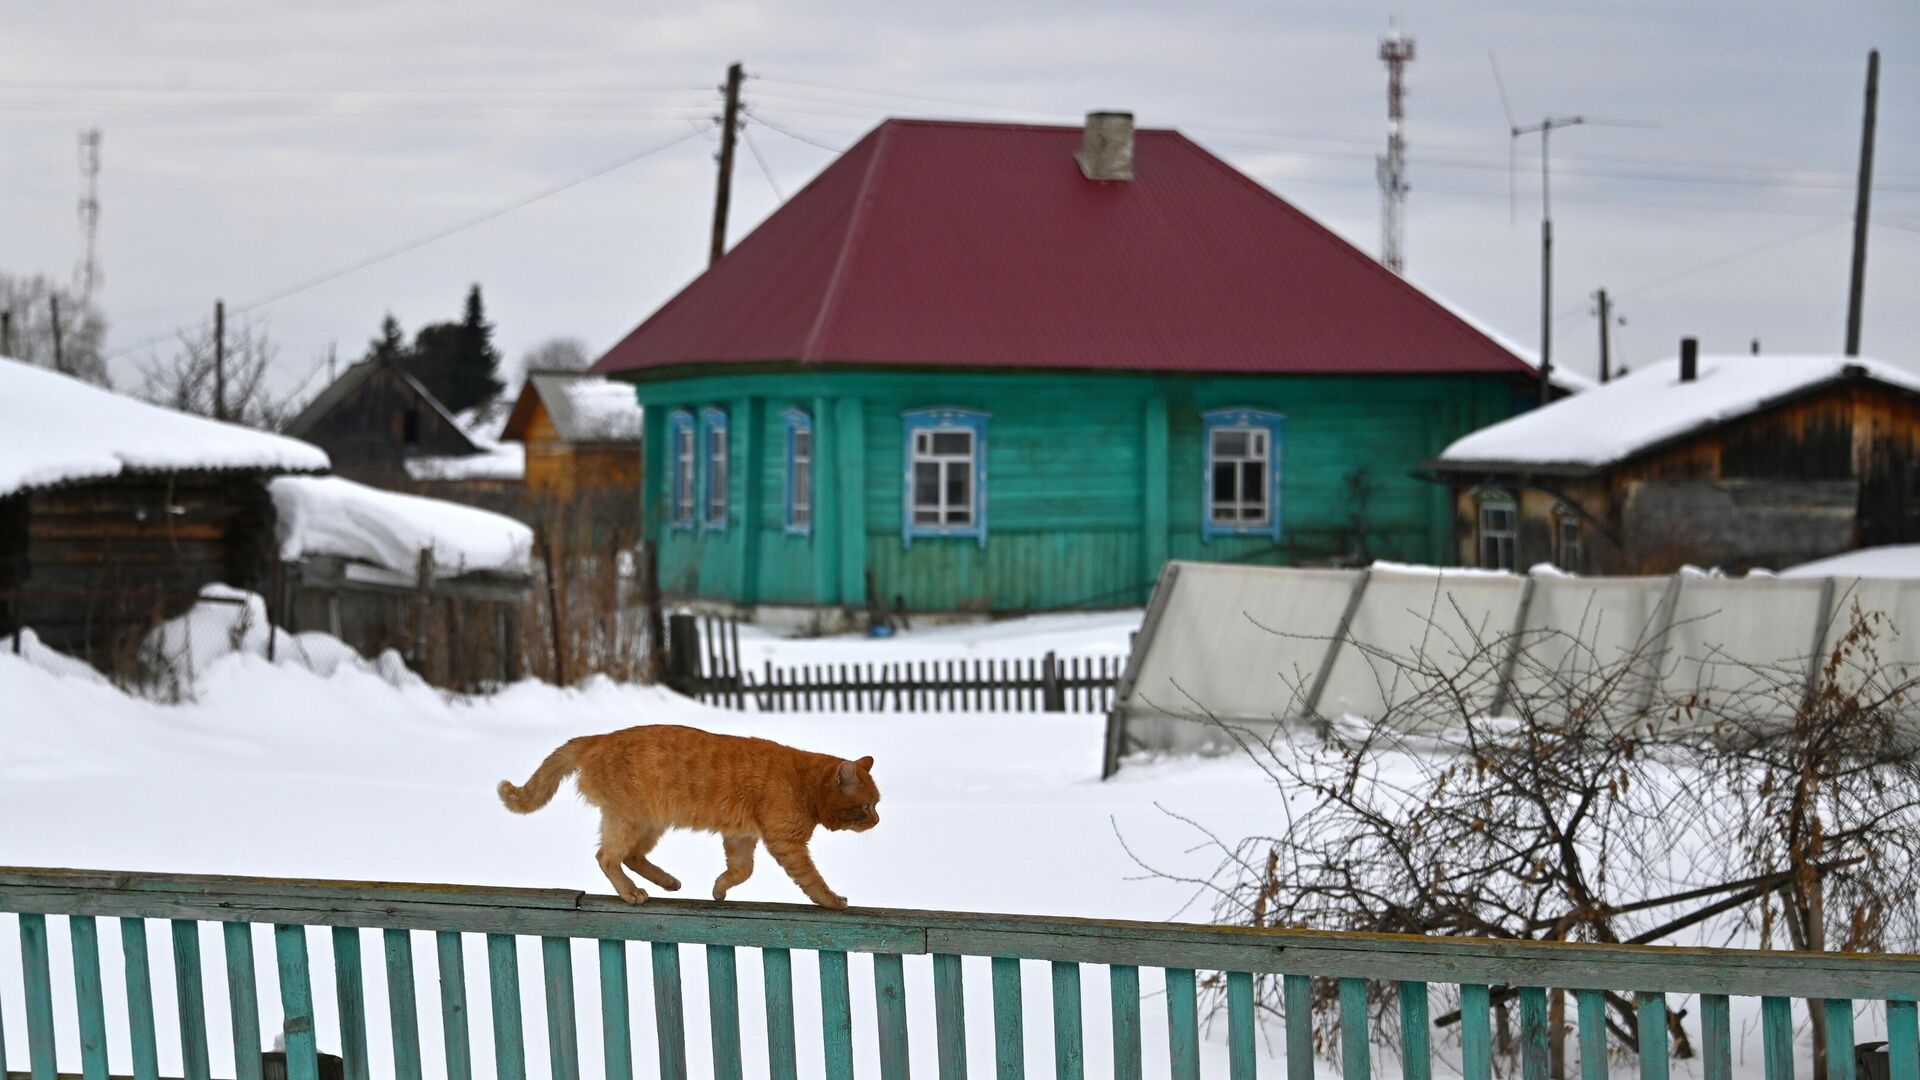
0,605,1868,1078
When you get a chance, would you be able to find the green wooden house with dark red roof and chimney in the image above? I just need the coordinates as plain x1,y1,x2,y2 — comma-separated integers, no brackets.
595,113,1536,611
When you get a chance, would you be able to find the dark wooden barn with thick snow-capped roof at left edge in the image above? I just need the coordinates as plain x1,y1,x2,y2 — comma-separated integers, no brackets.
0,359,326,667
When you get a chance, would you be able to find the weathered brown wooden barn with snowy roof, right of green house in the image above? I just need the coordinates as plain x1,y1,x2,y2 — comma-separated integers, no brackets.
1427,340,1920,575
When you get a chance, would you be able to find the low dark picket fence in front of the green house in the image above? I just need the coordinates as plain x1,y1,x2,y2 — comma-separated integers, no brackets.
666,615,1123,713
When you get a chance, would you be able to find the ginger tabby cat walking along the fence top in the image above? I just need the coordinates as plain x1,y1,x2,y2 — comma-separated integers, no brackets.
499,724,879,909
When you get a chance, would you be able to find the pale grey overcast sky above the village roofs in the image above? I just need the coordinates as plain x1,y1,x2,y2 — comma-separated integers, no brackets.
0,0,1920,403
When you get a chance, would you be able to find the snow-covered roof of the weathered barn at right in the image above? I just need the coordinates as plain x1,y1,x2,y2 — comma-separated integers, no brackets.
1434,354,1920,469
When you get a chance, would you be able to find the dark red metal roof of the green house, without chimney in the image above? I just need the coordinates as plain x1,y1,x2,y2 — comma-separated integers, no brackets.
593,119,1532,375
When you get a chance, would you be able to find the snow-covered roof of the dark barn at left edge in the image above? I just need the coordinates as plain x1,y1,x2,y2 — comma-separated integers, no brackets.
0,357,330,496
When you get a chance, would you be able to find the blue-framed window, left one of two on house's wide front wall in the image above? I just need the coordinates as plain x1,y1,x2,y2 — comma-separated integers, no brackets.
900,409,987,548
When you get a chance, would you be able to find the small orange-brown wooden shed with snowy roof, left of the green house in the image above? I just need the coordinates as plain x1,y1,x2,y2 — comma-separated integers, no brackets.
499,371,641,548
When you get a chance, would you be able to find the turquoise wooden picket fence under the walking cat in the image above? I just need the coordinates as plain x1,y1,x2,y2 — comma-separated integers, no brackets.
0,869,1920,1080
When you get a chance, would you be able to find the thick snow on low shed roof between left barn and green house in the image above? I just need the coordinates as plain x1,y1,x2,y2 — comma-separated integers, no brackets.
269,477,534,577
